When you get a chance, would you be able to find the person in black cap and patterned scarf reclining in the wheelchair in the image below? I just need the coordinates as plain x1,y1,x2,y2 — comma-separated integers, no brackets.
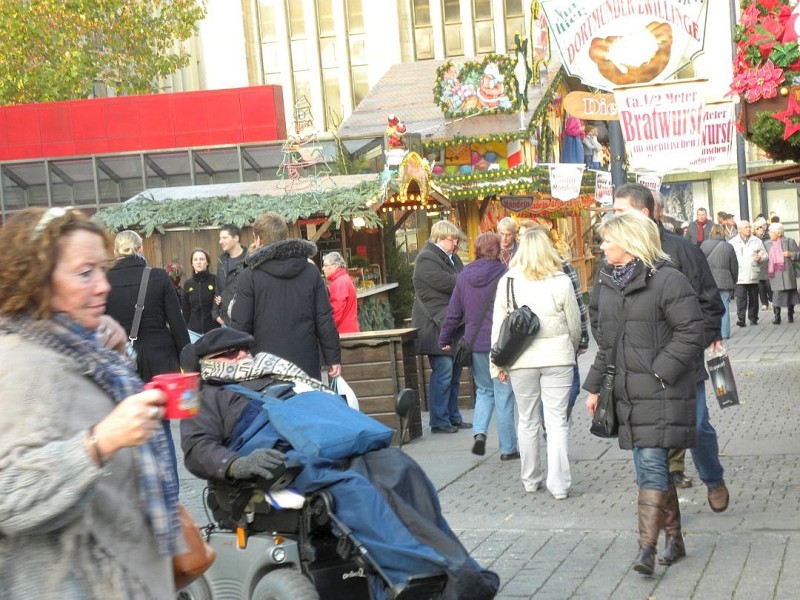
181,328,499,600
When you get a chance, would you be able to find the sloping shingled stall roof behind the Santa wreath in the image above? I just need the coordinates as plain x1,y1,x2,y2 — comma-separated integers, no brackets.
339,59,561,139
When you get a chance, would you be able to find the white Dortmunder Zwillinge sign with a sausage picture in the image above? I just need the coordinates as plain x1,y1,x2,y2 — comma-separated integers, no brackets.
542,0,707,90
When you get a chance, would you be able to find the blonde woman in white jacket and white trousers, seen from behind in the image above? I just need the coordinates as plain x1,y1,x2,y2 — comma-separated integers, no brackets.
491,229,581,500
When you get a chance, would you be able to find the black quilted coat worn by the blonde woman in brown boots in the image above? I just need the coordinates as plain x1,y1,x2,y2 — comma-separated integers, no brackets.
583,263,704,449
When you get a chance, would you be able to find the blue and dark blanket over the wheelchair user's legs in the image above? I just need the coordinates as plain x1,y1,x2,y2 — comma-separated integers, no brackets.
229,392,499,599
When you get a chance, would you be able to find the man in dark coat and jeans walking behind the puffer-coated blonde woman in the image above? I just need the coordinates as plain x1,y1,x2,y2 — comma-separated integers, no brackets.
614,183,729,528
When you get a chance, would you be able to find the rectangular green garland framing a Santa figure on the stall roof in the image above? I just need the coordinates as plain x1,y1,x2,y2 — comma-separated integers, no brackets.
433,54,521,117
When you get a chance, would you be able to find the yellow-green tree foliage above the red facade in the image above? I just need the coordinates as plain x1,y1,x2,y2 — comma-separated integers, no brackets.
0,0,206,105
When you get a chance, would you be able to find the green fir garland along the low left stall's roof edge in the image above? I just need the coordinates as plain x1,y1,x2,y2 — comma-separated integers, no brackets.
96,180,382,236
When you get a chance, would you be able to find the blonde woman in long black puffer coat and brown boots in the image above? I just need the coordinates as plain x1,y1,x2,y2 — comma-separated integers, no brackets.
583,211,703,575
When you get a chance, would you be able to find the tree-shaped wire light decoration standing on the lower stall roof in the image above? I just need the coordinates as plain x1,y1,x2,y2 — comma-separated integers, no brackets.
277,96,336,194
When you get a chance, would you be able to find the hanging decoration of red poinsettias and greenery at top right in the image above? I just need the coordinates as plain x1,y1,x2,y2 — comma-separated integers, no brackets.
729,0,800,161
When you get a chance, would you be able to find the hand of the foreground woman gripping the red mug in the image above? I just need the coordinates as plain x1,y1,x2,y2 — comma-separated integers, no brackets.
93,389,167,460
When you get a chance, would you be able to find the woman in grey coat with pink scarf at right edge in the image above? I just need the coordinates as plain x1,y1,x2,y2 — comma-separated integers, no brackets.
764,223,800,325
